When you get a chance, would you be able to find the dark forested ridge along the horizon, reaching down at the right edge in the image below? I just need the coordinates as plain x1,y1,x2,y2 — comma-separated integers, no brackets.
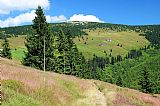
0,22,160,48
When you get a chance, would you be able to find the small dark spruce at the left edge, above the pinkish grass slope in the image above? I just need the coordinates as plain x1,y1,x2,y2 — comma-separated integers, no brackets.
1,37,12,59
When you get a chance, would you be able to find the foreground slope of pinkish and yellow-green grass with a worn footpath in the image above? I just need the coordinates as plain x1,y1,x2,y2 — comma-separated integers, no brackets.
0,58,160,106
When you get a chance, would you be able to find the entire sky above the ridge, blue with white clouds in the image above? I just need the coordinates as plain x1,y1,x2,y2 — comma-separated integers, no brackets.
0,0,160,27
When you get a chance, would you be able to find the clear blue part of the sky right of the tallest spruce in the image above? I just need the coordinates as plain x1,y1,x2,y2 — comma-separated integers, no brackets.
51,0,160,24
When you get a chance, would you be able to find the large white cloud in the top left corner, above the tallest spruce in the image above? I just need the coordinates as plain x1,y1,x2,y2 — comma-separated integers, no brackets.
0,0,49,14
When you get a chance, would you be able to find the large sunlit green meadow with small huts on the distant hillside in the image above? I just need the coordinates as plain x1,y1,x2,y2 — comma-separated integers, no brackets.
74,29,150,58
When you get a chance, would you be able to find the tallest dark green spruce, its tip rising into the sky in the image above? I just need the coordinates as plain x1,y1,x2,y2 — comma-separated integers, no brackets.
22,6,54,71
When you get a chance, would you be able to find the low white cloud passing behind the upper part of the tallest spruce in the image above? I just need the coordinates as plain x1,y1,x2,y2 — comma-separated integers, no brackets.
0,10,67,27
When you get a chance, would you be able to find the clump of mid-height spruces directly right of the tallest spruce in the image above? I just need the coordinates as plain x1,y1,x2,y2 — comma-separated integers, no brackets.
56,28,85,77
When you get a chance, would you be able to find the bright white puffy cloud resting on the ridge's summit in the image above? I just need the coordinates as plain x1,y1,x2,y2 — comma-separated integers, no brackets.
68,14,104,22
